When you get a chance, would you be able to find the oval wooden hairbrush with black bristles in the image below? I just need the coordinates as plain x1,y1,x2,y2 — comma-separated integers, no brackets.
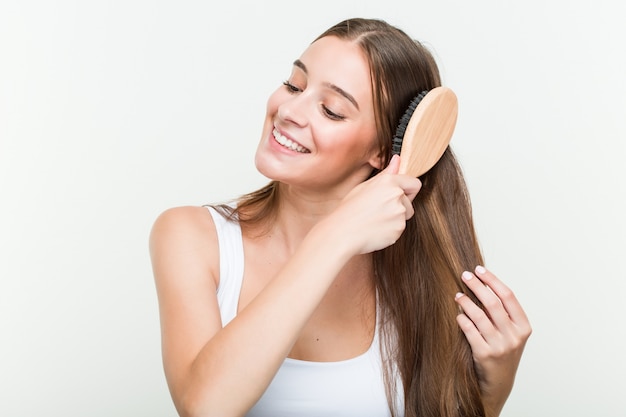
392,87,458,177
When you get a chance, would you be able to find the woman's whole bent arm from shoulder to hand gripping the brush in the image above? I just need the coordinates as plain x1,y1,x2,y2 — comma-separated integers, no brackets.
150,158,420,417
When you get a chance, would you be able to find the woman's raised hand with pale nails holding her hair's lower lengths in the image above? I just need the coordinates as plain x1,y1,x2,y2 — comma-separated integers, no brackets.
456,266,531,417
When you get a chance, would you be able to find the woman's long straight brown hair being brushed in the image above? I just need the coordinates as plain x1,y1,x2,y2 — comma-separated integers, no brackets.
219,19,484,417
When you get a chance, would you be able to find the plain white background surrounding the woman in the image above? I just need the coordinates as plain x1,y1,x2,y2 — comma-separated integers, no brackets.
0,0,626,417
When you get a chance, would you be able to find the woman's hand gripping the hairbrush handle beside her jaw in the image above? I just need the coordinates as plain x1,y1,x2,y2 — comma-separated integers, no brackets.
326,155,422,255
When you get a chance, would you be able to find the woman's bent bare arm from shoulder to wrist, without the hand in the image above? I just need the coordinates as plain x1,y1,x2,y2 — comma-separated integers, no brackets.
150,208,350,417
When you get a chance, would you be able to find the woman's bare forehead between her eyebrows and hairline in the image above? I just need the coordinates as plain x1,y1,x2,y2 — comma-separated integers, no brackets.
300,36,372,102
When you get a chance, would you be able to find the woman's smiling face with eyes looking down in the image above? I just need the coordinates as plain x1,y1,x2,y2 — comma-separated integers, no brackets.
255,36,380,193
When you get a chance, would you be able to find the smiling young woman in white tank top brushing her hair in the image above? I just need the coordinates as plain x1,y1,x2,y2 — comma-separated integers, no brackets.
150,19,531,417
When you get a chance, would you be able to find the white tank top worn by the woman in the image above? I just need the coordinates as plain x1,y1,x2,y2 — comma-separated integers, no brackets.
209,207,404,417
